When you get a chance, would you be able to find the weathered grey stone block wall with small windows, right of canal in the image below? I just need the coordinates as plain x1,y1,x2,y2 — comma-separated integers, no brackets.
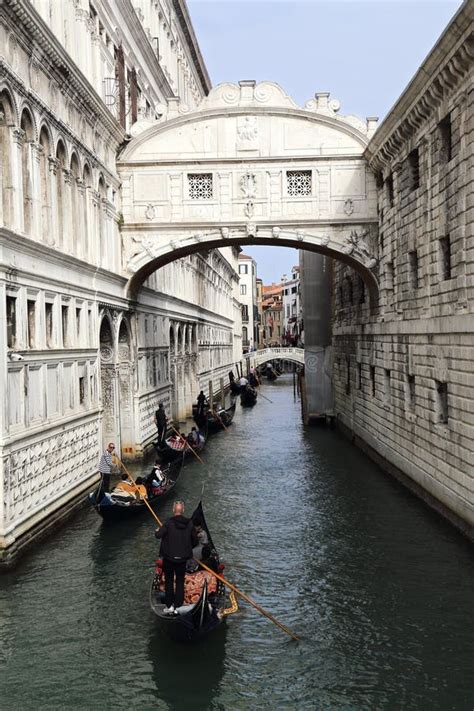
334,3,474,531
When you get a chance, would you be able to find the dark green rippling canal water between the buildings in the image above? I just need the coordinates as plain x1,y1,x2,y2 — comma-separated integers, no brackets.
0,376,474,711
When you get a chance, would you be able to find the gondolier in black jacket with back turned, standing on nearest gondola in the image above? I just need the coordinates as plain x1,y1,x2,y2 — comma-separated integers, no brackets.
155,501,199,615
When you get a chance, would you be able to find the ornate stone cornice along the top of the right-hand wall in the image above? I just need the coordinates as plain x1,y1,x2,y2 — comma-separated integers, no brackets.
364,2,474,171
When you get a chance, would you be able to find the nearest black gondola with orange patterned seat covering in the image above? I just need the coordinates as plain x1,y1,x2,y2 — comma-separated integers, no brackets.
150,503,238,642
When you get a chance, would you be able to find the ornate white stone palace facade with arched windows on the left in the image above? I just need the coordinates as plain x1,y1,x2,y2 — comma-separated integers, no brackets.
0,0,241,560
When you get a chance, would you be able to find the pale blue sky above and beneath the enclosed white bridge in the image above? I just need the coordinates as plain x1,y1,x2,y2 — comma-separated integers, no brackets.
188,0,462,283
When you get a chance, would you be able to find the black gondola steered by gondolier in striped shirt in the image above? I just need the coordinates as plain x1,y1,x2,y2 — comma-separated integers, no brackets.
89,455,184,521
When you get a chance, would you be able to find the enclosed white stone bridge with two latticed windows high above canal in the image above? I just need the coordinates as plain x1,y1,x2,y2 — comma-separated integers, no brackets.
118,81,378,308
